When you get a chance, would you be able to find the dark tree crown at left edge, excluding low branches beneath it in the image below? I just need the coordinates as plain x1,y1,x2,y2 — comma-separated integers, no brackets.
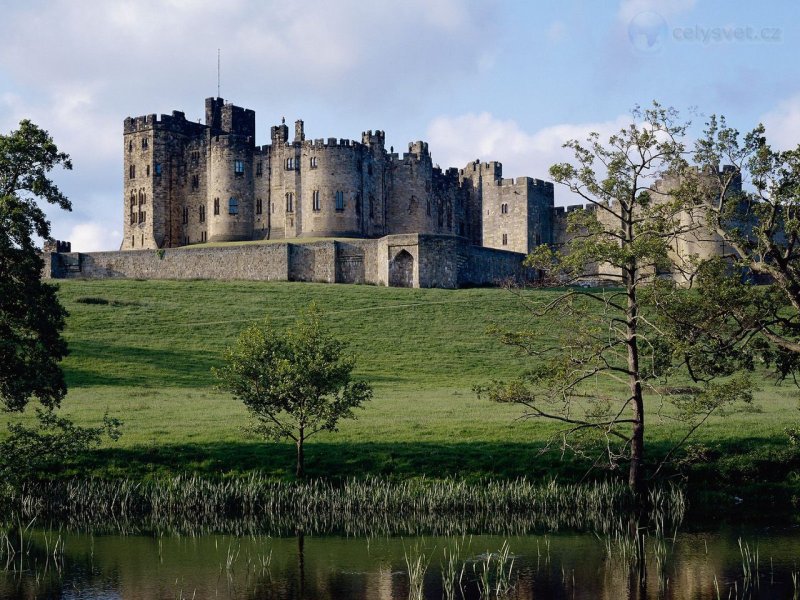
0,120,72,411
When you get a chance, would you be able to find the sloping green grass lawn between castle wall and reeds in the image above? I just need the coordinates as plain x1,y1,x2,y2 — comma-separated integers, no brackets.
7,280,800,502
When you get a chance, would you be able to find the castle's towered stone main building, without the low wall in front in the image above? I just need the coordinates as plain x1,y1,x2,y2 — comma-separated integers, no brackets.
121,98,553,253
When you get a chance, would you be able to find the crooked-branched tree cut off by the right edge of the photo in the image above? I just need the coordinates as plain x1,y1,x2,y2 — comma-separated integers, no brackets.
682,115,800,376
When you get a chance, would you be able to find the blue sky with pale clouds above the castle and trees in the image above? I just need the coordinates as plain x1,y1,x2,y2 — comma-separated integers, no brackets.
0,0,800,252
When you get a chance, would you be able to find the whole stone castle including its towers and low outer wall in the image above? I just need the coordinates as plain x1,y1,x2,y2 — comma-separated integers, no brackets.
46,98,732,288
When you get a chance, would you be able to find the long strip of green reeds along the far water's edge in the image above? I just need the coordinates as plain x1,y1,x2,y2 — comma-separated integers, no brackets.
5,474,685,542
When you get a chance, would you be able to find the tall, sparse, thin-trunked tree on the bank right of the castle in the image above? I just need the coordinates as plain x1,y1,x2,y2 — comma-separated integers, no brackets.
480,103,749,498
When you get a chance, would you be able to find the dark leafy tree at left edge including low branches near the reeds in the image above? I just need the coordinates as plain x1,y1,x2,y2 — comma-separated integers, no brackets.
0,120,120,486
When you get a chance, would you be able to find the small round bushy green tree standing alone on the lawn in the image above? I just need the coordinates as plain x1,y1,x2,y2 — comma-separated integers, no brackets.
214,304,372,478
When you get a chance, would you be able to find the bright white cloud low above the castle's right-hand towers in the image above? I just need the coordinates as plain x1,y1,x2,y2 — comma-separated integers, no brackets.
427,112,631,204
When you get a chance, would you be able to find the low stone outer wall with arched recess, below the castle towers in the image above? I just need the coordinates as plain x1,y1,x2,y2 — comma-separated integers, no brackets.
50,234,530,288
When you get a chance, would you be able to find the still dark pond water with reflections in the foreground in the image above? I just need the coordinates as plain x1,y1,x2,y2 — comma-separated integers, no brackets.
0,528,800,600
